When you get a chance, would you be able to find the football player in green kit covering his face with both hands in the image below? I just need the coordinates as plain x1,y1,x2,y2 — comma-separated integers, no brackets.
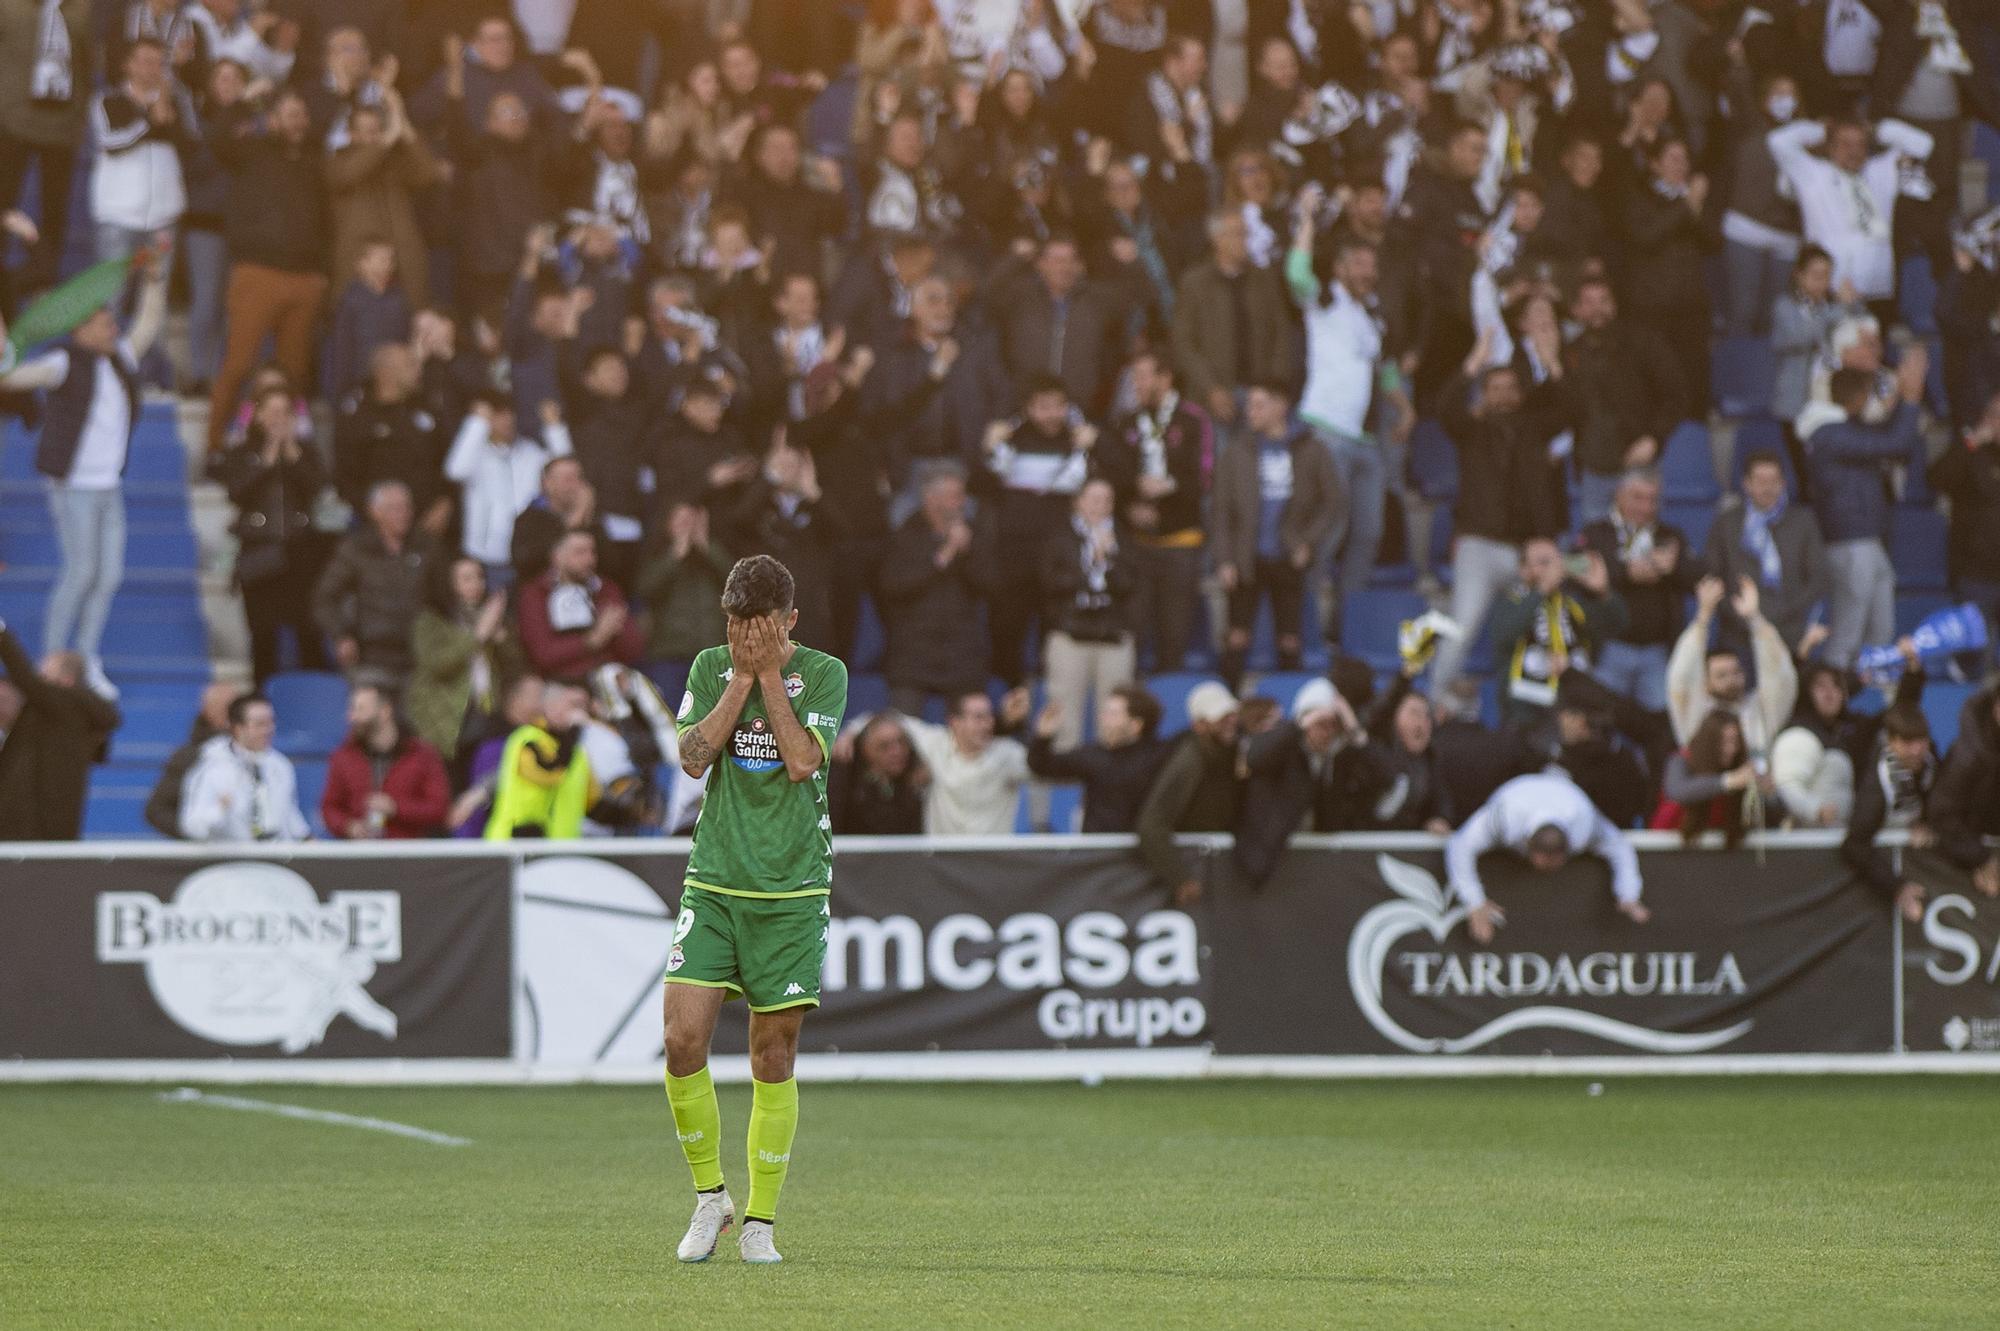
666,556,848,1263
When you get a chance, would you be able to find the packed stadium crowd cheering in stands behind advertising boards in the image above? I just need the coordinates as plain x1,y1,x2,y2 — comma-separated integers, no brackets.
0,0,2000,911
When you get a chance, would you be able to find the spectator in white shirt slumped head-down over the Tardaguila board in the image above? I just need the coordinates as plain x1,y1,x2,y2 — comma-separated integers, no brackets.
1444,775,1652,947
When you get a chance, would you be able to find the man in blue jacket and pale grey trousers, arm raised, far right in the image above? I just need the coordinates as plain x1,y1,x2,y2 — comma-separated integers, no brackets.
1800,348,1926,667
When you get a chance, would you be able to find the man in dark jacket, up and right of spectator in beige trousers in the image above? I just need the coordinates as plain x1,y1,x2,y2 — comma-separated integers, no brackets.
1092,352,1234,671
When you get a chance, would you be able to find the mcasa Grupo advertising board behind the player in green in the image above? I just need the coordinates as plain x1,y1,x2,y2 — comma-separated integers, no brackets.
518,841,1208,1065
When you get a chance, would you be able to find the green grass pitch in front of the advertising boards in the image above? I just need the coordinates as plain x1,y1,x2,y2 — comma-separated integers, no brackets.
0,1077,2000,1331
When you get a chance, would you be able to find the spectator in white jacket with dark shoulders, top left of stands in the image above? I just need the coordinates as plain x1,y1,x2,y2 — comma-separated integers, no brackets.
90,40,200,260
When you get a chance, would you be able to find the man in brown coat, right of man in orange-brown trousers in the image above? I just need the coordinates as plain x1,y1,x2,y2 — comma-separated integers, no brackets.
326,88,444,310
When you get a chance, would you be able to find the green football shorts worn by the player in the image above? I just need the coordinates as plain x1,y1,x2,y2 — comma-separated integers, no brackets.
666,883,832,1011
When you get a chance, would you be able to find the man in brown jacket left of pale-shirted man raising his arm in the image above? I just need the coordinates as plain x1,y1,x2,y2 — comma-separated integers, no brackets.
1174,210,1298,426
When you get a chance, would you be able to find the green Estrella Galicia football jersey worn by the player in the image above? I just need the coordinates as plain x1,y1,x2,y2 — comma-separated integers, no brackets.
678,646,848,897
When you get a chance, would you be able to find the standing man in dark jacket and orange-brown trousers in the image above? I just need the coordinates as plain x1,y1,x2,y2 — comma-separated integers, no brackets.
208,90,328,450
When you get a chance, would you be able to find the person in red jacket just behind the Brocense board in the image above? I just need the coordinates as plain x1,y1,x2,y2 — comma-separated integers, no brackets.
320,683,452,841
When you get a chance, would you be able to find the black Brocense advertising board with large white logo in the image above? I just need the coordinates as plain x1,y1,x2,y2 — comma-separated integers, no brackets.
0,855,512,1059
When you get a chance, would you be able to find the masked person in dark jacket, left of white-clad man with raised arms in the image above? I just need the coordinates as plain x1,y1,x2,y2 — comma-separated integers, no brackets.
1722,64,1798,338
